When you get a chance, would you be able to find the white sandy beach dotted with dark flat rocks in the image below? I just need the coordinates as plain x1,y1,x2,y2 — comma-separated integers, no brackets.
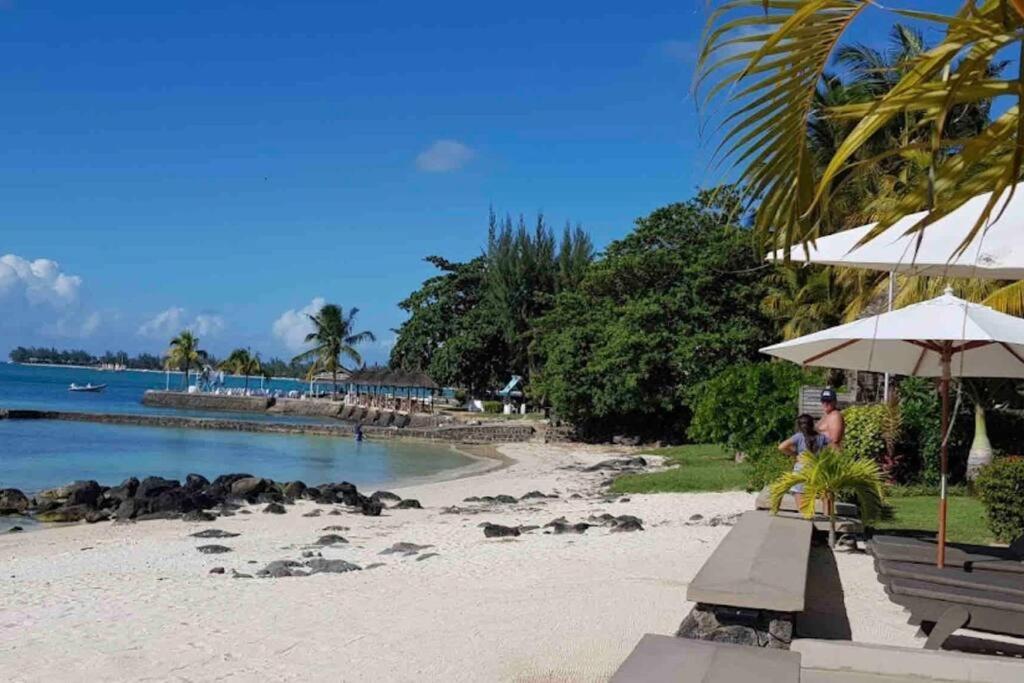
0,444,1007,681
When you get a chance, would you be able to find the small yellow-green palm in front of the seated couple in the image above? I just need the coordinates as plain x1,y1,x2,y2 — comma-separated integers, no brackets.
771,447,882,548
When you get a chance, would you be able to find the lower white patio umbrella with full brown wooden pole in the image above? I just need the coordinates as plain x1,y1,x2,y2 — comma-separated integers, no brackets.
761,290,1024,567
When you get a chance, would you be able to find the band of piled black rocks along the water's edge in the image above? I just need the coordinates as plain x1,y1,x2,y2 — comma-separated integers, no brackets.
0,473,395,523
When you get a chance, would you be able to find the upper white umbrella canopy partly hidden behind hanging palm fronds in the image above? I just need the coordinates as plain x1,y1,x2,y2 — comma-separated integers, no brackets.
768,183,1024,280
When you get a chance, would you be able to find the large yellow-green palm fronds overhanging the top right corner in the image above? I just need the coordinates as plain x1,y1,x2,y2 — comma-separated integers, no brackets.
696,0,1024,255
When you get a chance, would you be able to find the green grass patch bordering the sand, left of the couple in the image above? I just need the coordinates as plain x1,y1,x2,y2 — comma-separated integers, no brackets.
611,443,746,494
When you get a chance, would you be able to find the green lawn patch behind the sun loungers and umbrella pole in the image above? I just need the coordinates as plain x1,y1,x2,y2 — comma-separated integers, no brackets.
874,496,994,544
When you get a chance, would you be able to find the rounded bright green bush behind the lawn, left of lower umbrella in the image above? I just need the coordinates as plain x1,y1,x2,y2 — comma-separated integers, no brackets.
687,361,821,452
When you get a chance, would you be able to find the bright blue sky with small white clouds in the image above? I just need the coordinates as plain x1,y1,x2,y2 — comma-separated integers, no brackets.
0,0,958,360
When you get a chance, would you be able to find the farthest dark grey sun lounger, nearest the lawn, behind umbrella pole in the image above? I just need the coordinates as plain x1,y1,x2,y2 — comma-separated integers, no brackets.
867,535,1024,573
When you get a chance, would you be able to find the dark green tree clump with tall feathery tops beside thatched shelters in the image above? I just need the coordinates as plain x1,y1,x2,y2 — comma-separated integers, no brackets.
390,213,593,396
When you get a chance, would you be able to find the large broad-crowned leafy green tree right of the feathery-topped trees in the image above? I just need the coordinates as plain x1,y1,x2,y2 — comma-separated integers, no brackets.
531,193,775,436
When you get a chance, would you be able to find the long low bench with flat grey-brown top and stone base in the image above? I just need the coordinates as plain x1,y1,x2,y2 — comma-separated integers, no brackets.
676,510,813,648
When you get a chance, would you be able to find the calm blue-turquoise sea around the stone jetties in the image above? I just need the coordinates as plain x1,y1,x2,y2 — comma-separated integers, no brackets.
0,364,470,499
